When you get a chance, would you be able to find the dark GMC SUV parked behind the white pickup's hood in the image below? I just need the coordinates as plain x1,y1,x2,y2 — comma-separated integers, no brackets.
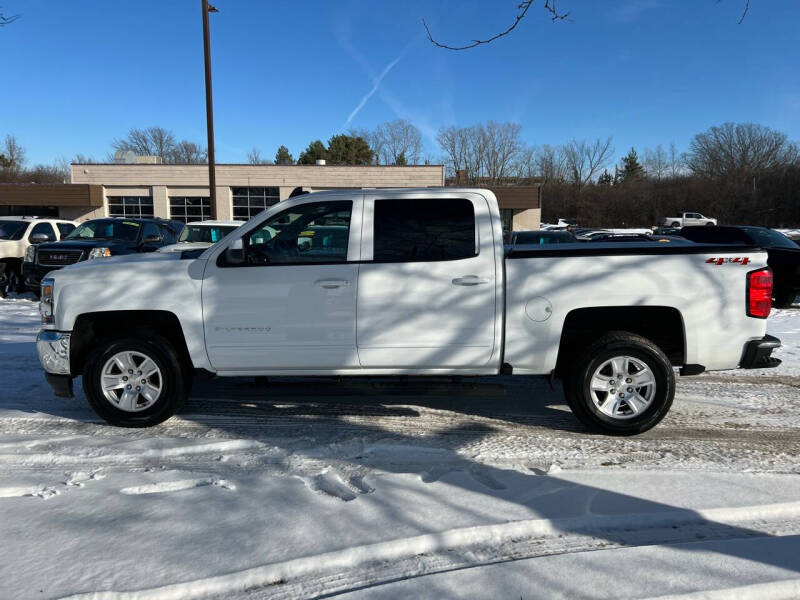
22,217,184,294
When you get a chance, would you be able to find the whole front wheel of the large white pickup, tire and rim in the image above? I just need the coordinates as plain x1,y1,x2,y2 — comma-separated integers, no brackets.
83,334,188,427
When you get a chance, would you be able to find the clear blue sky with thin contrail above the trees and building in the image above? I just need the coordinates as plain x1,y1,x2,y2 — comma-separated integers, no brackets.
0,0,800,163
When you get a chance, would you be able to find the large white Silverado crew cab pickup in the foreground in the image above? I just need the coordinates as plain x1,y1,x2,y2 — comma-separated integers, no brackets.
37,188,780,434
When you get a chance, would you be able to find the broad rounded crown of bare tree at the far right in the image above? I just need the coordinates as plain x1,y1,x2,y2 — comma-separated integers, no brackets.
686,123,800,179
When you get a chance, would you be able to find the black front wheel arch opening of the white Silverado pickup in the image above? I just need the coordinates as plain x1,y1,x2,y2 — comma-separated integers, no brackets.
70,310,193,375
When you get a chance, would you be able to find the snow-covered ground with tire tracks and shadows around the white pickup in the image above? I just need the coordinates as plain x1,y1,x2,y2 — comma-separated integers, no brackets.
0,297,800,600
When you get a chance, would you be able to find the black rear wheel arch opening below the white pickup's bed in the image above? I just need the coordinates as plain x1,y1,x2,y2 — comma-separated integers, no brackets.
556,306,686,376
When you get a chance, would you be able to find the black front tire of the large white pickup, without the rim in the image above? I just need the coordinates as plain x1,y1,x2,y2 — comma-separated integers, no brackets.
83,334,191,427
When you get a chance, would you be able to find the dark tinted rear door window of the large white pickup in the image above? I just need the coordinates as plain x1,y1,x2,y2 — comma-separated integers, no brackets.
373,198,477,262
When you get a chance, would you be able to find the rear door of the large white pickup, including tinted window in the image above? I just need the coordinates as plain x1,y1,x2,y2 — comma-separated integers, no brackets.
356,191,494,369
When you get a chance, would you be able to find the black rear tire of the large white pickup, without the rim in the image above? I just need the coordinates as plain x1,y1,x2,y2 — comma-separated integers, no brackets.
564,332,675,435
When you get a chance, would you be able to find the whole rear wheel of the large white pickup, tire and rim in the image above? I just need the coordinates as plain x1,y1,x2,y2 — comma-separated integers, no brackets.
564,332,675,435
